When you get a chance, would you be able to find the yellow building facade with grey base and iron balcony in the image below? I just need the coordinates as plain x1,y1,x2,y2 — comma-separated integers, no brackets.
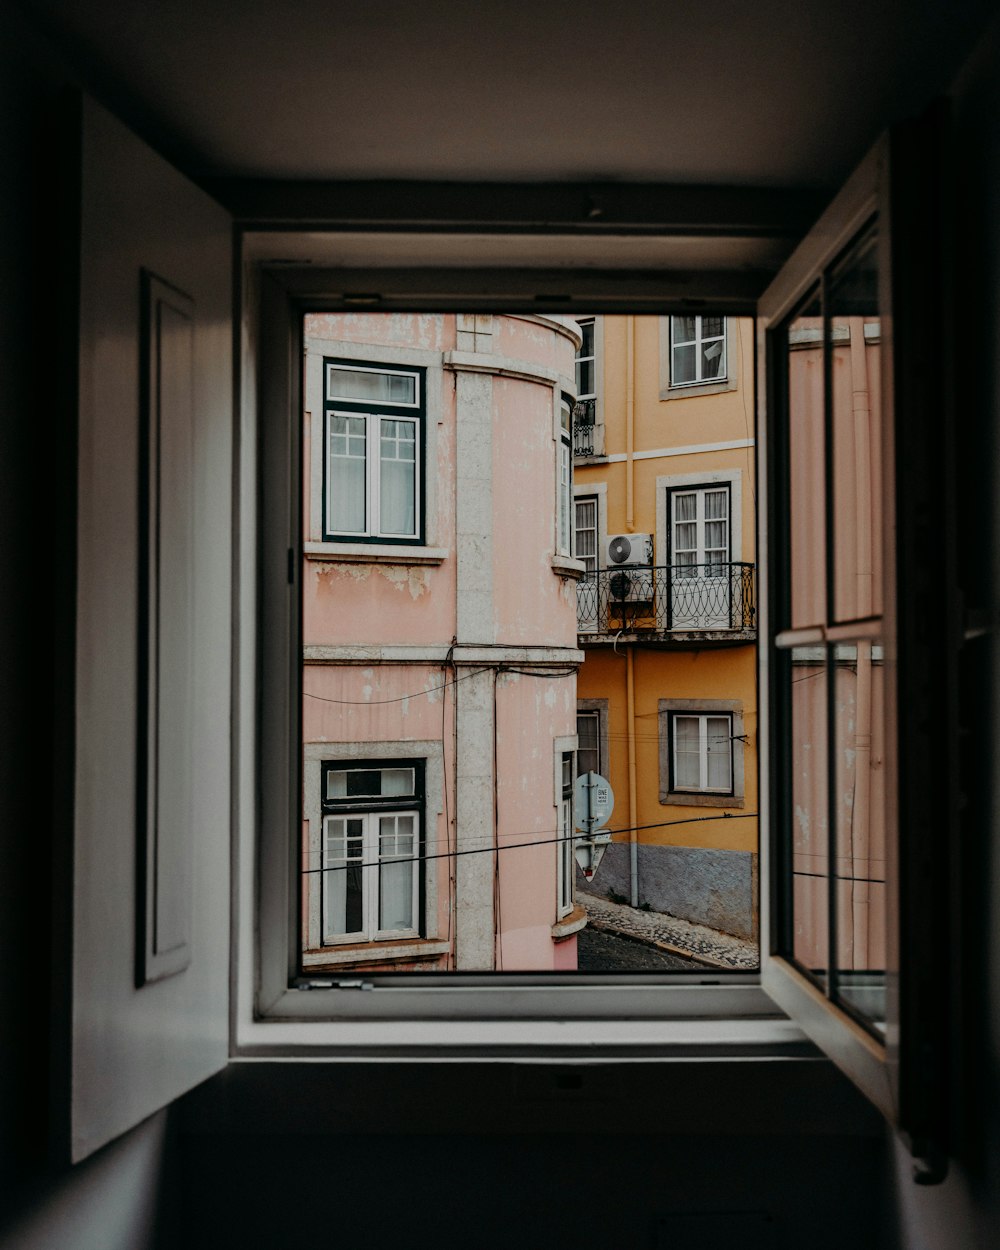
574,315,758,938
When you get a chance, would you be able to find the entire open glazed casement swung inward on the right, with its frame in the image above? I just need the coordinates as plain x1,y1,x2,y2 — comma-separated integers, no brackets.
758,133,954,1178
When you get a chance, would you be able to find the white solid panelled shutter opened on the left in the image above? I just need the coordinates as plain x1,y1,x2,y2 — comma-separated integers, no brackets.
64,99,234,1160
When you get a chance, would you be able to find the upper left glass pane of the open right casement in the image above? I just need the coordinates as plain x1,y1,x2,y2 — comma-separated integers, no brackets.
783,290,826,628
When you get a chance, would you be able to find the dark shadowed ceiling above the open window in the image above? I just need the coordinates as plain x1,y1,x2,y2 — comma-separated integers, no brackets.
21,0,996,189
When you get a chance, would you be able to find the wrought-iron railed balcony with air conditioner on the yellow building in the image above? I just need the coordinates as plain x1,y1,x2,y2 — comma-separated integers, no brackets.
576,563,756,646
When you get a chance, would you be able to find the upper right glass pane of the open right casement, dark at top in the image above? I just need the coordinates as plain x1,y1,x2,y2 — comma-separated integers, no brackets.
829,235,881,621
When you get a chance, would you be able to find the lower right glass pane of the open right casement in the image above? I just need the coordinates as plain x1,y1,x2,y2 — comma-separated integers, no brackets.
835,641,886,1024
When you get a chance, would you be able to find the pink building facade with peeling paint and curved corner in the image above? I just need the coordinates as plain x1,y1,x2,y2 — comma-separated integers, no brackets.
301,314,584,971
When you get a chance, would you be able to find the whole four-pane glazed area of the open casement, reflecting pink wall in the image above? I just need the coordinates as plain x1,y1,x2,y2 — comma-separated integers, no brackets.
774,226,889,1036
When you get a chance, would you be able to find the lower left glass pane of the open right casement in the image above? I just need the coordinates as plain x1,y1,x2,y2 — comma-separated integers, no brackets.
784,646,830,981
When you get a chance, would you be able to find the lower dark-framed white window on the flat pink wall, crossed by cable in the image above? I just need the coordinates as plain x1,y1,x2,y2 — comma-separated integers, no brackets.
320,761,423,946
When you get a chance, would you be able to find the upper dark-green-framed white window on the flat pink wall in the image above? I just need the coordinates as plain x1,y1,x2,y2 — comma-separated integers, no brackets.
324,360,424,543
